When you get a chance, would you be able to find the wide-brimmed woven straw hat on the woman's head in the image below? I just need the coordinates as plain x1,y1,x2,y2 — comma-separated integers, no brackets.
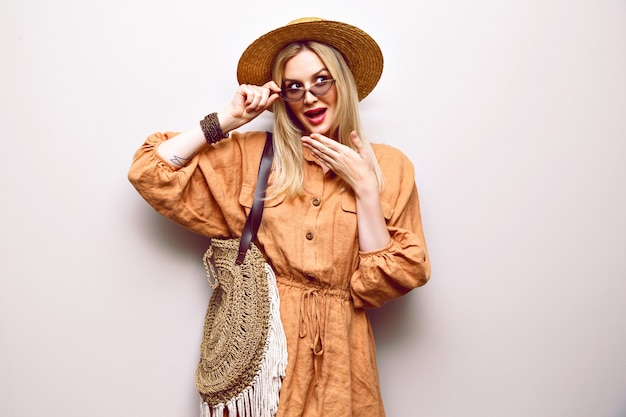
237,17,383,100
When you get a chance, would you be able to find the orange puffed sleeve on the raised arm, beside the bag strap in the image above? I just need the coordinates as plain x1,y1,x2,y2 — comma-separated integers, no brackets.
128,132,265,238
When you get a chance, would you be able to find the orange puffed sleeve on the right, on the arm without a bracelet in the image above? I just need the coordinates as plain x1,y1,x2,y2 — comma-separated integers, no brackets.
350,145,430,308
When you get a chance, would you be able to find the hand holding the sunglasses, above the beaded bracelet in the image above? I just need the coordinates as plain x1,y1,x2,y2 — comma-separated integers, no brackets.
219,81,280,132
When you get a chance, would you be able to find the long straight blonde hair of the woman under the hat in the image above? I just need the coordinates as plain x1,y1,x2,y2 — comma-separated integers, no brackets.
267,41,383,198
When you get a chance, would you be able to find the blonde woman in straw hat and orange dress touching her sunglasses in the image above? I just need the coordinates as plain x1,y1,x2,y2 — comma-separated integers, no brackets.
129,18,430,417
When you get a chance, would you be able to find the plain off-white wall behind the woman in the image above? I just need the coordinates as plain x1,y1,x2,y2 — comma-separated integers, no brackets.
0,0,626,417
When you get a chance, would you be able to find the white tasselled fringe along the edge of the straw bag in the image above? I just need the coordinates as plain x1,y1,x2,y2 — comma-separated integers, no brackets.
200,263,287,417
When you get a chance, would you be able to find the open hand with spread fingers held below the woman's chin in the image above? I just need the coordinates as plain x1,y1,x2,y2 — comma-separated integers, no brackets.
302,131,378,196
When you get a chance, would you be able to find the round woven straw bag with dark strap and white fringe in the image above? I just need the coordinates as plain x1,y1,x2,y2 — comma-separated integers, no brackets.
196,132,287,417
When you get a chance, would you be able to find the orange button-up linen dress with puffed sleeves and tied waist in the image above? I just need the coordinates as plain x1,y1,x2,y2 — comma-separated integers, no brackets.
129,132,430,417
